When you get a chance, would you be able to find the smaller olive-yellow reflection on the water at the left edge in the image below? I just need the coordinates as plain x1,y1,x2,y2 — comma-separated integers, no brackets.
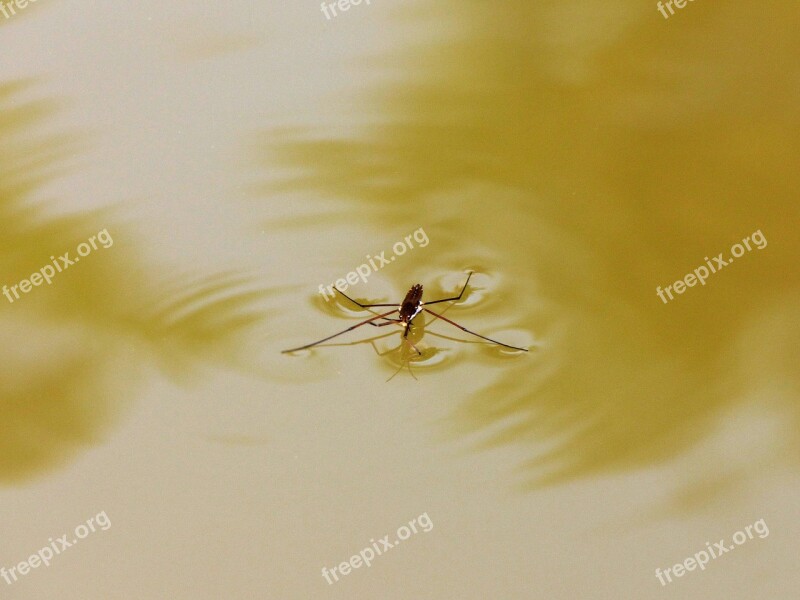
0,83,272,482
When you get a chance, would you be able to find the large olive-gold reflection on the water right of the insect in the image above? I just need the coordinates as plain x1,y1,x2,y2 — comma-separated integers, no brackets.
269,0,800,489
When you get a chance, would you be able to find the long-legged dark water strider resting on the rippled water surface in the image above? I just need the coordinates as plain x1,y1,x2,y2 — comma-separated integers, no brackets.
283,271,528,355
